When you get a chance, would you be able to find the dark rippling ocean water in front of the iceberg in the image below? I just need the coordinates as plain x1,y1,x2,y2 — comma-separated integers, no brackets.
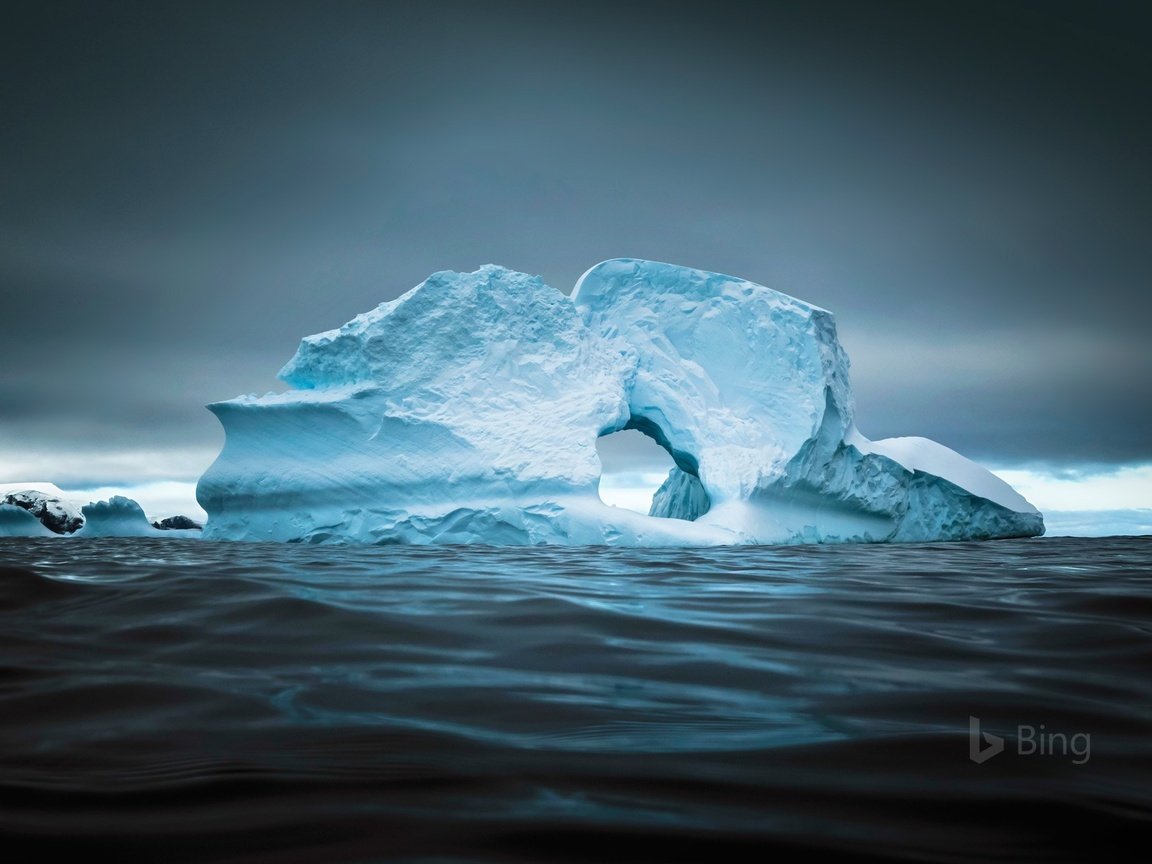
0,538,1152,862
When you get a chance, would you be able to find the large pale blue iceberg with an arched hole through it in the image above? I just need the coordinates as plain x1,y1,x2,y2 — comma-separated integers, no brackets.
197,259,1044,545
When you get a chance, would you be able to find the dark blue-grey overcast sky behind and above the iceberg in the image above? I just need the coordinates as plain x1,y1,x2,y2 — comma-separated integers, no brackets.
0,0,1152,499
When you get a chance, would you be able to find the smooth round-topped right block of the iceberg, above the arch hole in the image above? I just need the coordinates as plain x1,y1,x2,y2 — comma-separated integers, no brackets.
573,259,852,505
